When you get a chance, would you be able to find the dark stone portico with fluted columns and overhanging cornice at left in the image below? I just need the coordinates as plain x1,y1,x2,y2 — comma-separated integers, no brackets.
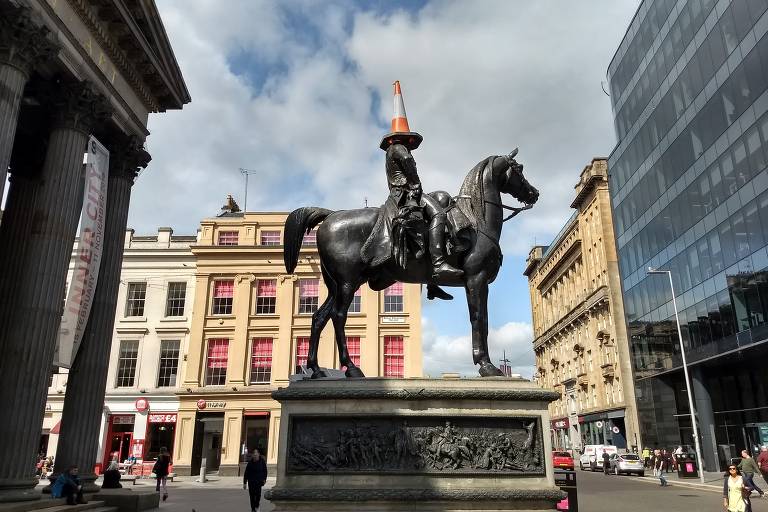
0,0,190,502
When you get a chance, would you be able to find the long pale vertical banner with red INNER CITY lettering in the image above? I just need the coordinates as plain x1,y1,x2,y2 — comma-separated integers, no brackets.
53,137,109,368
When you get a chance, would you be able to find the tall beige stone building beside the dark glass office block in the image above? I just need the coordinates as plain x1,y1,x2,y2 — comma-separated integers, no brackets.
525,158,641,449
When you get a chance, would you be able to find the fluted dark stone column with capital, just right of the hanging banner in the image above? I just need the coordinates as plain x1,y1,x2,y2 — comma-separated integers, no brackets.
54,137,149,492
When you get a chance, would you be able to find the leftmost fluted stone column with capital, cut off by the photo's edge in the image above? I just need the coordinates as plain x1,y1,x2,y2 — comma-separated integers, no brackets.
0,2,58,197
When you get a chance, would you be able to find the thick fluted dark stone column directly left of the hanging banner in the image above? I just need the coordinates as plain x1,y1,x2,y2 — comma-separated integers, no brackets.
0,82,107,502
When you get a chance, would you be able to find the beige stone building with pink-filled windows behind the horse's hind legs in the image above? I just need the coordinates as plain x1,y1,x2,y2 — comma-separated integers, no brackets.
174,212,422,475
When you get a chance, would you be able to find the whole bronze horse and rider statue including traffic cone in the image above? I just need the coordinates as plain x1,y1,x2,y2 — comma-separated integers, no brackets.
283,82,539,378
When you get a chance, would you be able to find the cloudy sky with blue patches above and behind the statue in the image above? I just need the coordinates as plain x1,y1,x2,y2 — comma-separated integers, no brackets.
129,0,638,376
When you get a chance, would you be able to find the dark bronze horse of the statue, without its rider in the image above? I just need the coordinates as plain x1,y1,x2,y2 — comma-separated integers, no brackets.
283,150,539,378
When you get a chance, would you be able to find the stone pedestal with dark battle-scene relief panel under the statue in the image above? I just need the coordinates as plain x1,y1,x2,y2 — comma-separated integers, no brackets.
267,378,565,512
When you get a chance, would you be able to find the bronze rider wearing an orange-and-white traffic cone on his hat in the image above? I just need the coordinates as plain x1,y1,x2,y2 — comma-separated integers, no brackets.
364,82,464,300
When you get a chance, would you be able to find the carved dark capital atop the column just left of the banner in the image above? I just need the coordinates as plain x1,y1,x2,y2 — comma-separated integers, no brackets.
39,78,113,135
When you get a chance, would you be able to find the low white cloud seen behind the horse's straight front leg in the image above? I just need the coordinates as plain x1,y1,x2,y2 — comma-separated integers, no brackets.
421,316,535,378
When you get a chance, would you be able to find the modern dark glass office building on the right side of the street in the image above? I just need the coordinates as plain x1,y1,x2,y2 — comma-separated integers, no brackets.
608,0,768,470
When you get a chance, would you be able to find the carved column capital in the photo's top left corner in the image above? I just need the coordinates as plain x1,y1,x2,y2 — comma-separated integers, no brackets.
0,2,59,76
